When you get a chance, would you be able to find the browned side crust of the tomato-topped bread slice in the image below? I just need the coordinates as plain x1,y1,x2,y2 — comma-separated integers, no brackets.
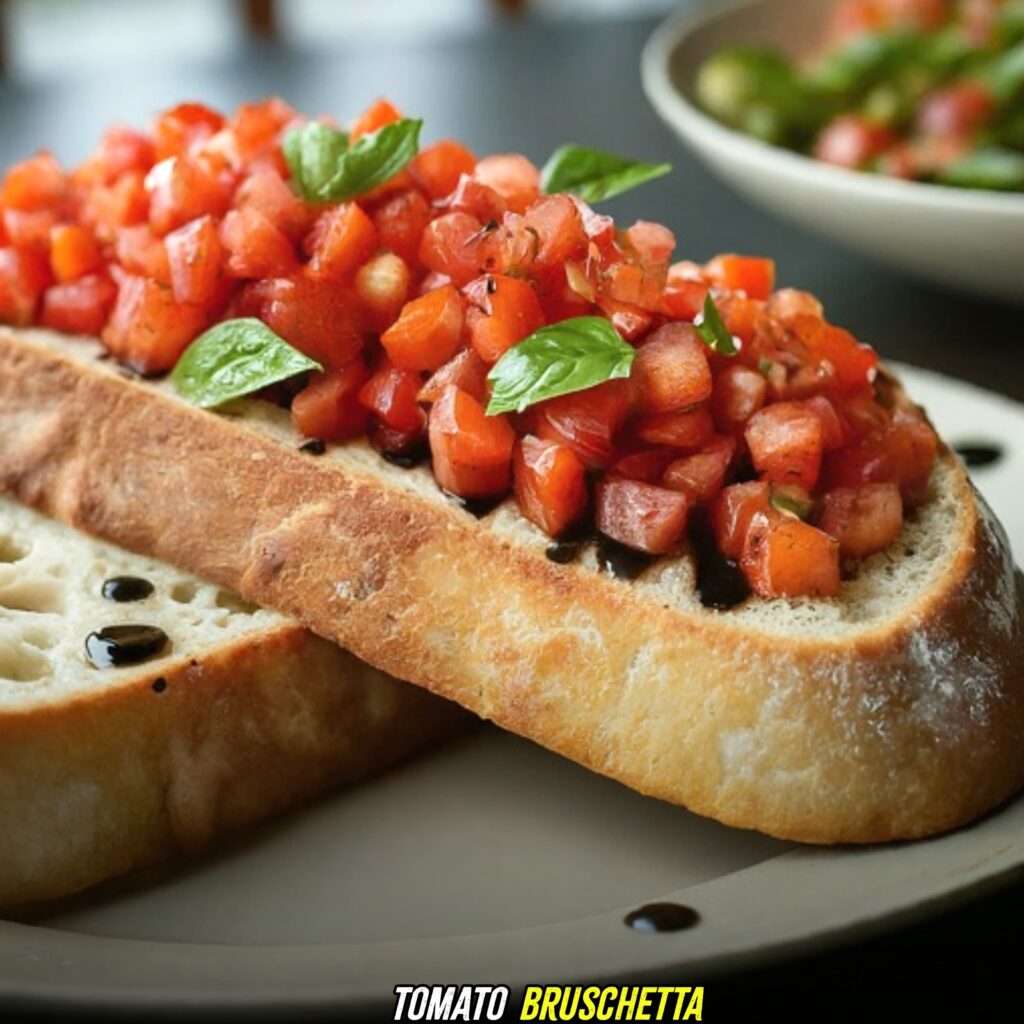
0,332,1024,843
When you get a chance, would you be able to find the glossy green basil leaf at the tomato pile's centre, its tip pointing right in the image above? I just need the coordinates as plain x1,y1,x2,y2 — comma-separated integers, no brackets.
487,316,636,416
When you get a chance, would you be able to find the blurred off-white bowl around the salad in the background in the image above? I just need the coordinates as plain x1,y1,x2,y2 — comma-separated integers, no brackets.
642,0,1024,303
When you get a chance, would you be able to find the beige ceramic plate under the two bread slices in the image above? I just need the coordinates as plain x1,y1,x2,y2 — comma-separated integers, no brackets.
0,369,1024,1013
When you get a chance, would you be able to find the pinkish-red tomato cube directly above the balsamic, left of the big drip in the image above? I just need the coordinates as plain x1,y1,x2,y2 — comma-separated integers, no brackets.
595,477,690,555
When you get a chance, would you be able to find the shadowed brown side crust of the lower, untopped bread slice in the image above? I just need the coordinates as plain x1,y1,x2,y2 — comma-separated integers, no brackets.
0,625,469,907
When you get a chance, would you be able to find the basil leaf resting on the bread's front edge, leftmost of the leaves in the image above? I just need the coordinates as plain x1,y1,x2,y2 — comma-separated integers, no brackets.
171,317,324,409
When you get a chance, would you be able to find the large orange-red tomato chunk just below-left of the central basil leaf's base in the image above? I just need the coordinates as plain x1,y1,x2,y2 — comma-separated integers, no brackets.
429,386,515,498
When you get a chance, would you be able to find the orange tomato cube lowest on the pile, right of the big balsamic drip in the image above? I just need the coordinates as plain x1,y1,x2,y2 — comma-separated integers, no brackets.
740,512,840,597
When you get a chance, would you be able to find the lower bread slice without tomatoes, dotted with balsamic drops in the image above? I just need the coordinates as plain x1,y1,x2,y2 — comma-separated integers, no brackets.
0,491,468,906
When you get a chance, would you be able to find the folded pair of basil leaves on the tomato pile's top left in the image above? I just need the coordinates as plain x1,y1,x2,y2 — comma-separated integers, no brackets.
285,118,423,203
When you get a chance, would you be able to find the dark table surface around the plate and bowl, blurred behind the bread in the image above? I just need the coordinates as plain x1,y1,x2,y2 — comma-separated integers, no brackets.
0,8,1024,1019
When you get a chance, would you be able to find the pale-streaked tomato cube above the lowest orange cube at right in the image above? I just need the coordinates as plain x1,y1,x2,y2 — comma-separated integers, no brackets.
744,401,824,490
